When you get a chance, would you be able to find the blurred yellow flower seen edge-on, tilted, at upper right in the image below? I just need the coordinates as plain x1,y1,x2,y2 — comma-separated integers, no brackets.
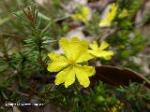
99,3,118,27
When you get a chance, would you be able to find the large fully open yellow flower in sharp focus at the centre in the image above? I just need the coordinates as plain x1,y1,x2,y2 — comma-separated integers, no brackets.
47,37,95,88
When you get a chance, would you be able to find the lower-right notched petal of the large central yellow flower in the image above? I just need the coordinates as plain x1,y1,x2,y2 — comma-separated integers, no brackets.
75,65,95,88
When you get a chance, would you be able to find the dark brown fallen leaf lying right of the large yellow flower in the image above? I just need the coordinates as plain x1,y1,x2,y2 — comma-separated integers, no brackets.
92,65,150,88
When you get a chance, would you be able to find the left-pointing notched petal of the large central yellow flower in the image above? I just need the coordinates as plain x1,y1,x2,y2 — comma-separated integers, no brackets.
47,53,68,72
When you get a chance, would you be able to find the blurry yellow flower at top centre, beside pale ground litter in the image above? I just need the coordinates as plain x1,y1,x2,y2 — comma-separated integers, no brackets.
71,6,91,23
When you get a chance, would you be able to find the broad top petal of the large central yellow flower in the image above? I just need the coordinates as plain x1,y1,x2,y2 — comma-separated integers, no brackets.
59,37,88,61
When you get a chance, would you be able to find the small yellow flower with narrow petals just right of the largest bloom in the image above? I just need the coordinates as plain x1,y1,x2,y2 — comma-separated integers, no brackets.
89,41,114,60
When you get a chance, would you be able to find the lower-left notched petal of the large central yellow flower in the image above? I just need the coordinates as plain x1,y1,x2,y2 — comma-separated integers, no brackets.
55,67,75,88
